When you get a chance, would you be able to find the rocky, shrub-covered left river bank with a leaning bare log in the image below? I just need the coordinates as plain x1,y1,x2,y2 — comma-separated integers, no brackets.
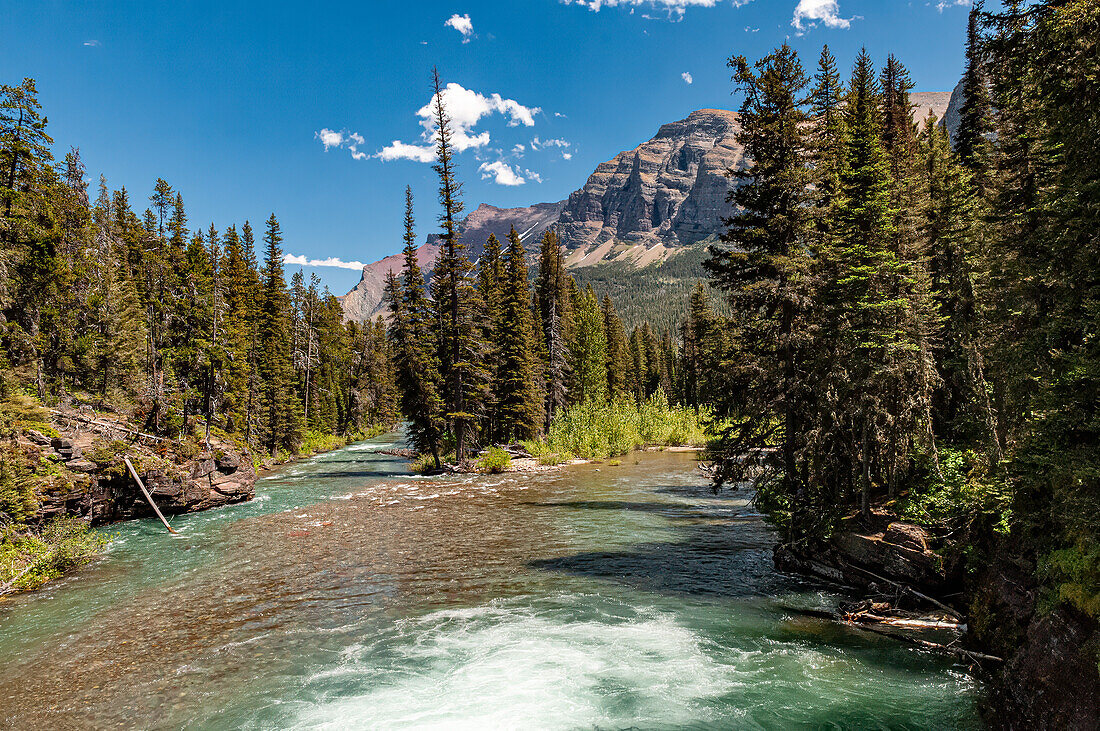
0,408,383,598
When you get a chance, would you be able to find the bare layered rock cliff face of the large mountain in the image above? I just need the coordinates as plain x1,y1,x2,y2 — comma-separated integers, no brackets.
554,109,743,266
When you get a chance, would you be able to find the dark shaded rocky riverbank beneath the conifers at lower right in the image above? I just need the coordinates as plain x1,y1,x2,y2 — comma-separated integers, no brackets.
774,512,1100,729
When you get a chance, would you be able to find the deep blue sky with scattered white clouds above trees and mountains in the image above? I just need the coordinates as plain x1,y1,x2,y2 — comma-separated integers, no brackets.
0,0,969,293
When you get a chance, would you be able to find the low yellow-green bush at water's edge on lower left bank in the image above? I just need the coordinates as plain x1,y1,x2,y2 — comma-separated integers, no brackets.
0,518,109,591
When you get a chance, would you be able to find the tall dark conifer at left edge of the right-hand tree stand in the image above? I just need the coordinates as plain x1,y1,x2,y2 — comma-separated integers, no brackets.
705,45,813,495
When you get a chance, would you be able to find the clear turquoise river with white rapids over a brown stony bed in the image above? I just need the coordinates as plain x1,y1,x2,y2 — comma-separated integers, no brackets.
0,435,979,729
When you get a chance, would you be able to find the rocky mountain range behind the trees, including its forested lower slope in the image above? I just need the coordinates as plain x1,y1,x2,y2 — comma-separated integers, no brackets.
342,95,958,324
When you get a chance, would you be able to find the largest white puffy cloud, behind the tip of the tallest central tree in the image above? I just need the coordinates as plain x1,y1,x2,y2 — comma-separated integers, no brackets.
375,82,542,163
